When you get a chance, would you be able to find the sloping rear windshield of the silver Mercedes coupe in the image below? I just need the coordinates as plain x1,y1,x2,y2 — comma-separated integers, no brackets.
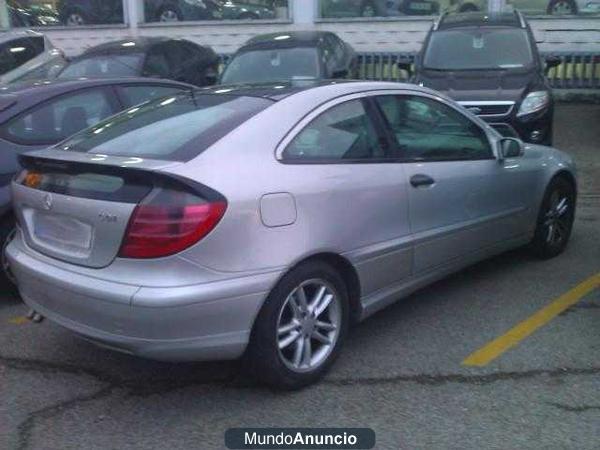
57,91,273,161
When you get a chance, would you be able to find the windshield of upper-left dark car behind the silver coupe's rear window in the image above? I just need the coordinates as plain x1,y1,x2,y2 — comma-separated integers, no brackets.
58,53,143,78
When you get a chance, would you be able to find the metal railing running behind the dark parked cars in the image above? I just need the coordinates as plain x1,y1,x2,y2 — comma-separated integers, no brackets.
221,51,600,89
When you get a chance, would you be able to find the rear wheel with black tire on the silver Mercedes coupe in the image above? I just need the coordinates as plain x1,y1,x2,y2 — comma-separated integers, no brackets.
244,261,350,390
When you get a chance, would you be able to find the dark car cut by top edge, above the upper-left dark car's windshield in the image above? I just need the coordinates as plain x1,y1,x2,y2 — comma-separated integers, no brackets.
57,0,123,26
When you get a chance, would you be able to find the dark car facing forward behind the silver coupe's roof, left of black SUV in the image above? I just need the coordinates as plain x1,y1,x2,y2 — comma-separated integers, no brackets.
221,31,358,84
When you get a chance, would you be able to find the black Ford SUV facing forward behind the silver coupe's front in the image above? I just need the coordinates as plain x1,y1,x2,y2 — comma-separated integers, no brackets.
400,12,559,145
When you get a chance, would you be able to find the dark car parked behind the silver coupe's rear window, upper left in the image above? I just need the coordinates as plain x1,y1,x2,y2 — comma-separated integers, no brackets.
58,37,219,86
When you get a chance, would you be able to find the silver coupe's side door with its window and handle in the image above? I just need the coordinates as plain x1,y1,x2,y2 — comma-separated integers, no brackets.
376,94,531,275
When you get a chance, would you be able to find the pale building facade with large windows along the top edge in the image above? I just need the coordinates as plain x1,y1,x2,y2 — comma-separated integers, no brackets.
0,0,600,56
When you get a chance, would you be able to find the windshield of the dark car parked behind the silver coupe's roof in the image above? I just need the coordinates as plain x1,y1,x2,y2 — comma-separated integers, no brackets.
221,47,319,84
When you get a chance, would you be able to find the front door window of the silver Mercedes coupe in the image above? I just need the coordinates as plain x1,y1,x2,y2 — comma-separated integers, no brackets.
376,95,493,161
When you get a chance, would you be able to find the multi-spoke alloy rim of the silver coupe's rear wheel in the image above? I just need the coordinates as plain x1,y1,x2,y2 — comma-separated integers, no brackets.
276,279,342,372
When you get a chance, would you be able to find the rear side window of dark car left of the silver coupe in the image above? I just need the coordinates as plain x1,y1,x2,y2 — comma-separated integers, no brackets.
3,89,113,145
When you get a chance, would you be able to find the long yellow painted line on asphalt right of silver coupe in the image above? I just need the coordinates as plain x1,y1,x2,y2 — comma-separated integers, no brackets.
462,273,600,367
